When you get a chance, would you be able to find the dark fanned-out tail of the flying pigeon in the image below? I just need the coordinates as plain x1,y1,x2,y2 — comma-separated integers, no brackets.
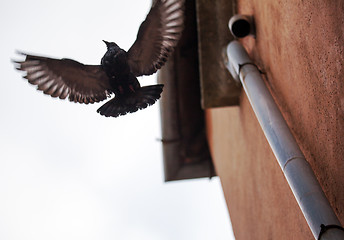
97,84,164,117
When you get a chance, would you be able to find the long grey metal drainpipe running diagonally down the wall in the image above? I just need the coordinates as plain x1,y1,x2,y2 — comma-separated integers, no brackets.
227,41,344,240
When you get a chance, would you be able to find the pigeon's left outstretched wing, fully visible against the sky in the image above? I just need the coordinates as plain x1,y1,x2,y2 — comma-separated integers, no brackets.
14,53,111,104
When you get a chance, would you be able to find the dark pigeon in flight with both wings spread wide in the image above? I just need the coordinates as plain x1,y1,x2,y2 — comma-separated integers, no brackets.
14,0,184,117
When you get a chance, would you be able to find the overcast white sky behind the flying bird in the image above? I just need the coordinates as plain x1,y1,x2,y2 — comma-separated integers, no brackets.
0,0,232,240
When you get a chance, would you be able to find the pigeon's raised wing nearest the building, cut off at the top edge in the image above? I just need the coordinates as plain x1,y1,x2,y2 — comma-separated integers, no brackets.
128,0,184,76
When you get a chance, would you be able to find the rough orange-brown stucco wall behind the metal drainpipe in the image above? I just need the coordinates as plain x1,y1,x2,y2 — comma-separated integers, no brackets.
207,0,344,239
